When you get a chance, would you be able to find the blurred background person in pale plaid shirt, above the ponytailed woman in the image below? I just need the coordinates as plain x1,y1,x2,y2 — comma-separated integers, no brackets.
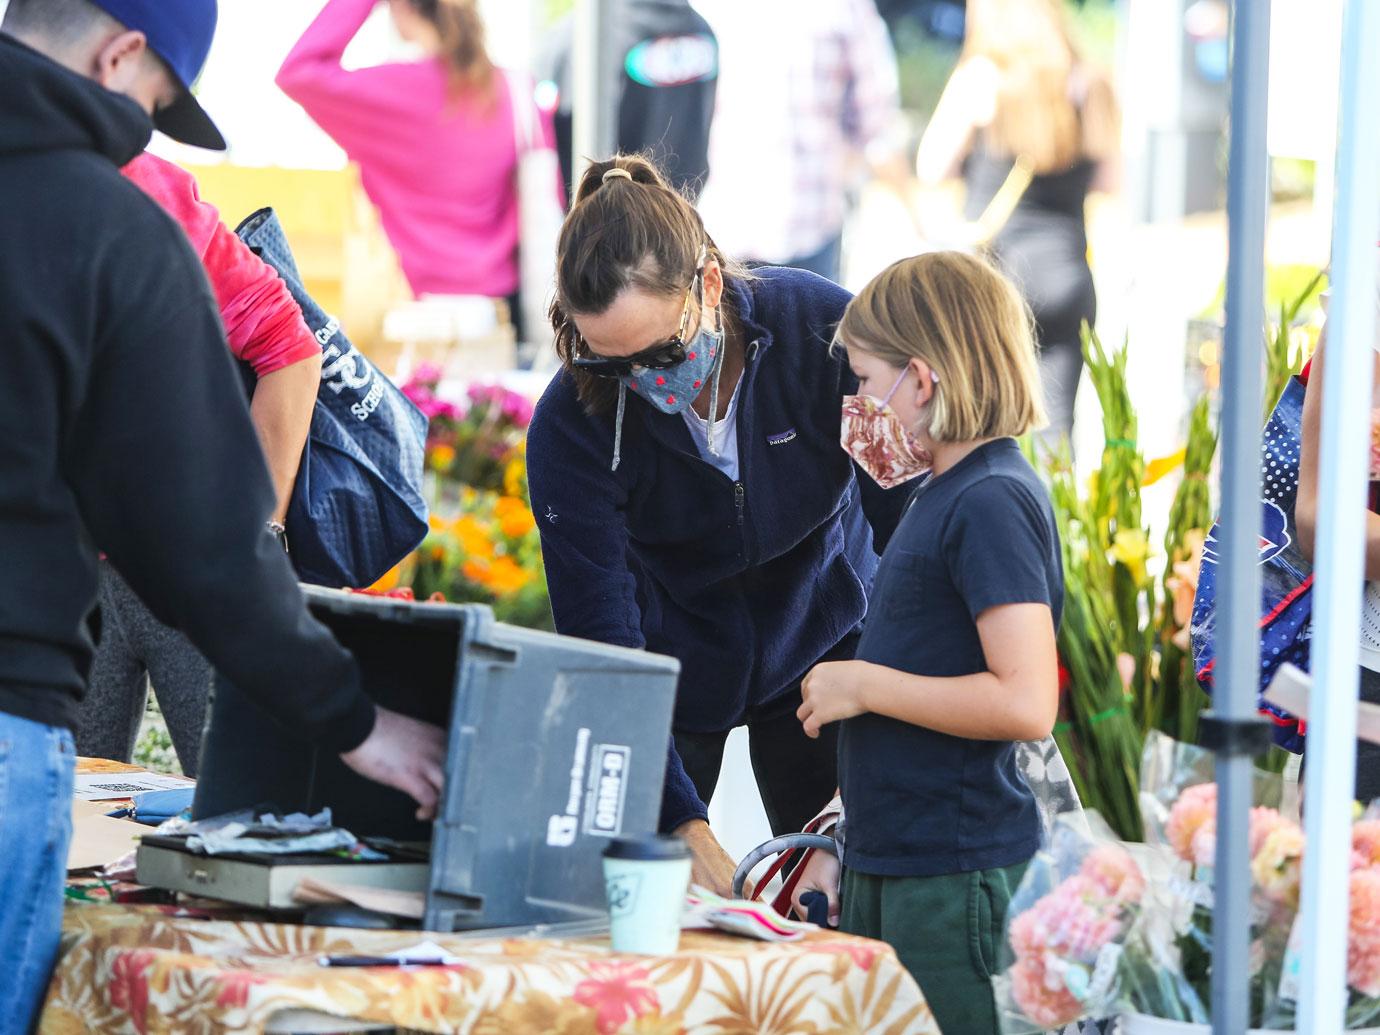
697,0,905,282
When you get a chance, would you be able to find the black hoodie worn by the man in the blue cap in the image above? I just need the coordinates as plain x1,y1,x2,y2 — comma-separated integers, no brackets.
0,35,374,752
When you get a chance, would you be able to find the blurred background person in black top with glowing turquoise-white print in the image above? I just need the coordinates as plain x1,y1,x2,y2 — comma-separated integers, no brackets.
540,0,719,199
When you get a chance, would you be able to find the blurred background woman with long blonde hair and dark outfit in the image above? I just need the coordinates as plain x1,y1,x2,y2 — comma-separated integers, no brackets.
915,0,1121,443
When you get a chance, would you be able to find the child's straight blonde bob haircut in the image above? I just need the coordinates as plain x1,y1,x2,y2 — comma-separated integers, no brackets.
835,251,1046,442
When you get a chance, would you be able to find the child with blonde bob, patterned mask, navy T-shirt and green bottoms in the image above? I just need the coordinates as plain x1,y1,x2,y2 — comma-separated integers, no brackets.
799,253,1064,1035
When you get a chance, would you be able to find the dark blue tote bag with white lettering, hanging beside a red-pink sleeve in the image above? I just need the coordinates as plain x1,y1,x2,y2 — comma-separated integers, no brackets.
236,208,426,588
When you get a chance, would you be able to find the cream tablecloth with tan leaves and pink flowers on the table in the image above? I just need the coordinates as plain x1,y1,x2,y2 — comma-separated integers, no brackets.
41,904,938,1035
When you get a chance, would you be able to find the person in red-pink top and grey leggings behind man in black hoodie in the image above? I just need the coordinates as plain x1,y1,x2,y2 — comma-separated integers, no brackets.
75,152,322,776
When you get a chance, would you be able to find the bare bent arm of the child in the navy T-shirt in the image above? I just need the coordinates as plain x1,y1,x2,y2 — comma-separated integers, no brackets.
796,603,1058,741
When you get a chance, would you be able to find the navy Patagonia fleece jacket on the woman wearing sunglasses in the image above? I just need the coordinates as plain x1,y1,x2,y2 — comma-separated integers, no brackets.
527,268,909,831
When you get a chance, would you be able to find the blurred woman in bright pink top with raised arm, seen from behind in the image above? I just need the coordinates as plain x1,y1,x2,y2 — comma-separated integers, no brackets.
276,0,560,338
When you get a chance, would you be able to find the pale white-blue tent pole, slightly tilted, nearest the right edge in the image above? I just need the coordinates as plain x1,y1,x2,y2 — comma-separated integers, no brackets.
1299,0,1380,1035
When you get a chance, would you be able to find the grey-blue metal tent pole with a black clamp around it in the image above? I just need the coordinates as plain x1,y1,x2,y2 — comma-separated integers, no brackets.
1203,0,1270,1035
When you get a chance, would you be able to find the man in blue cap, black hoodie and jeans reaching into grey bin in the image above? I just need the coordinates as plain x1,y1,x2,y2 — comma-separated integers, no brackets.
0,0,444,1032
